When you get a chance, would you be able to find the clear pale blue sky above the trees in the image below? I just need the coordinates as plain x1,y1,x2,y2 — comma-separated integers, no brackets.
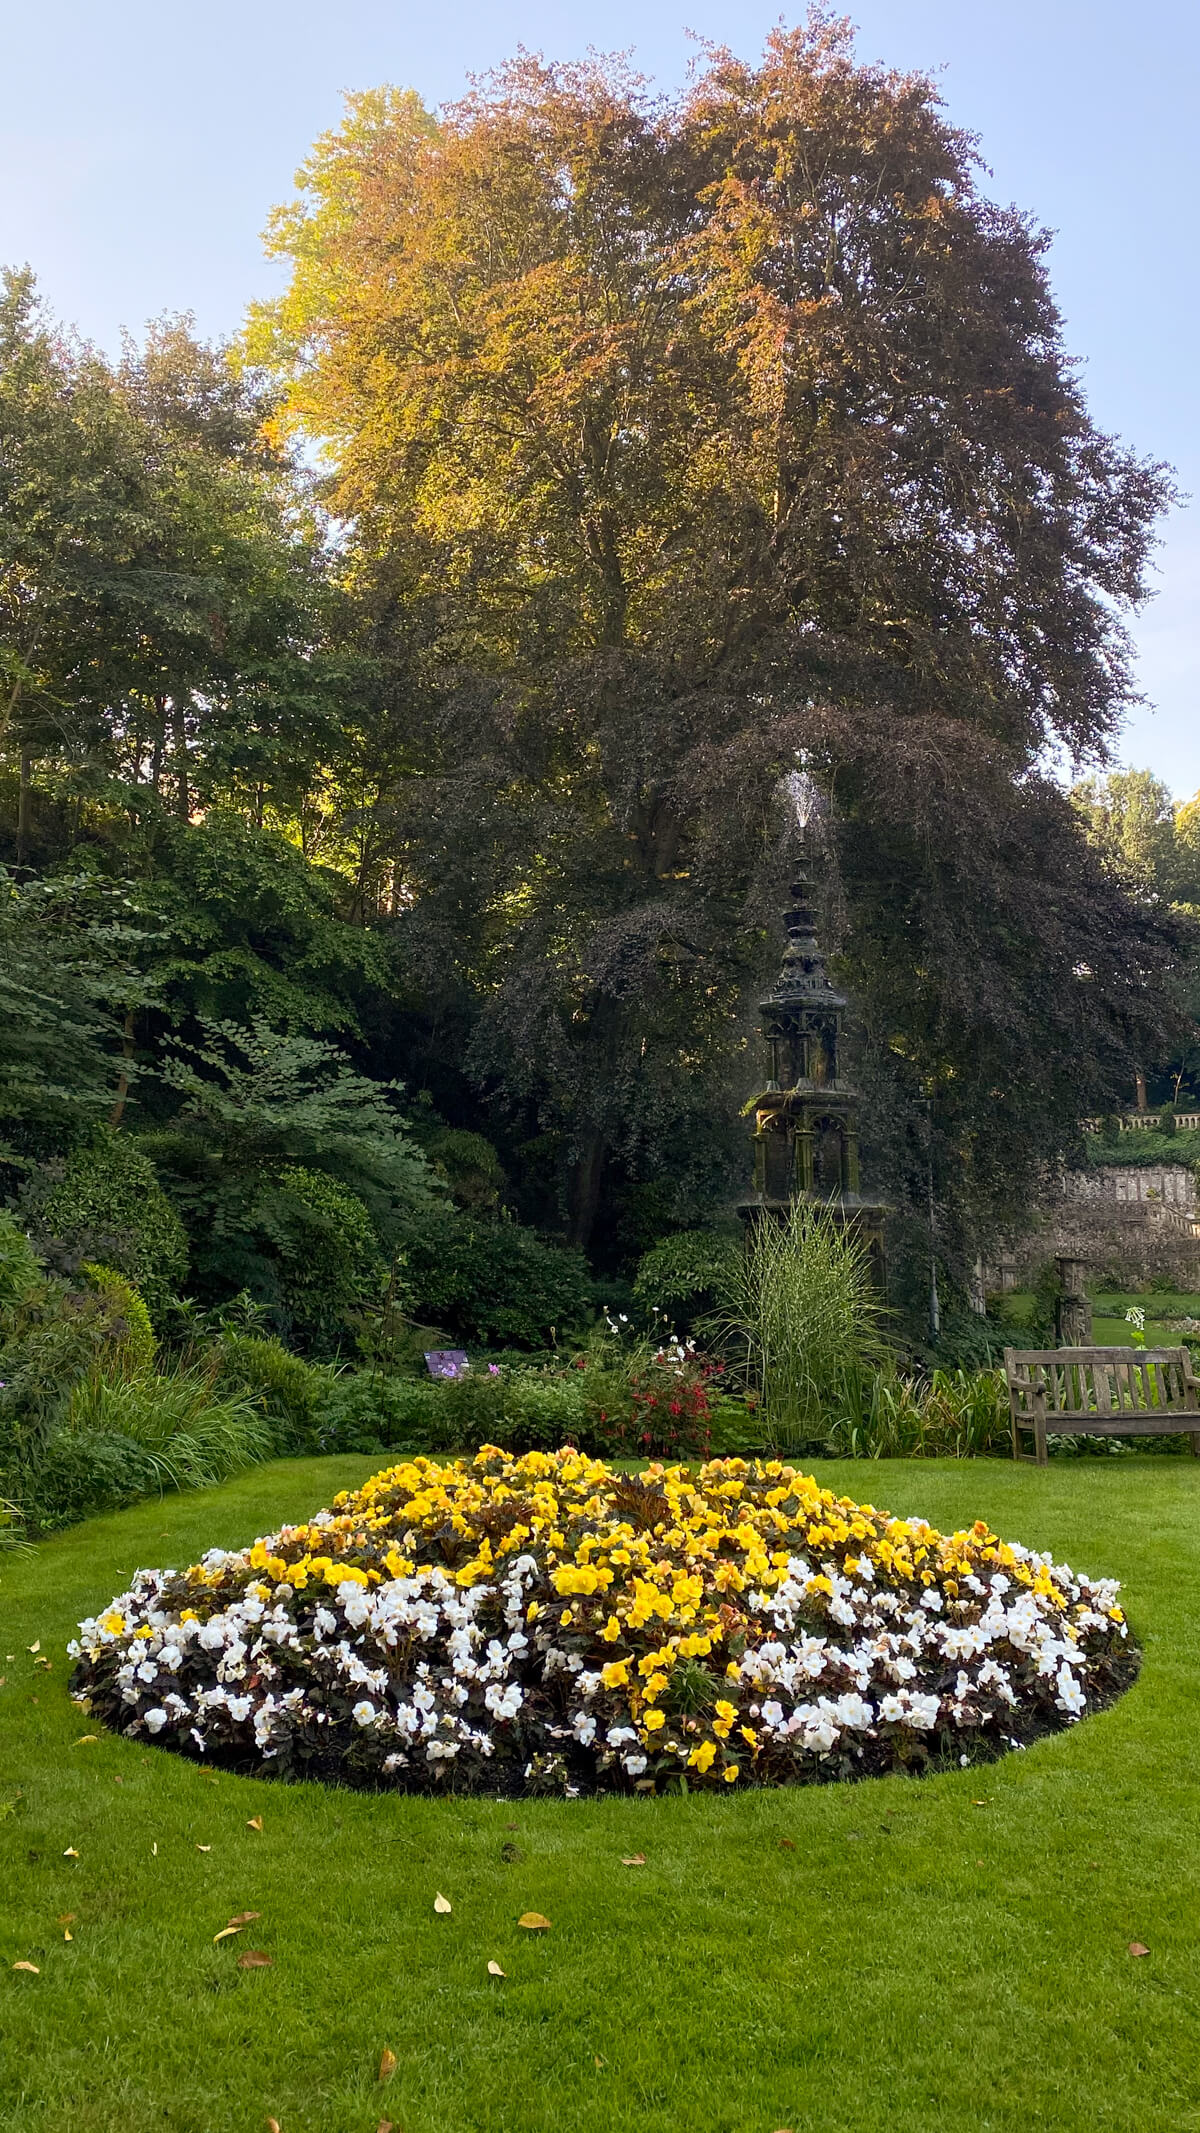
0,0,1200,796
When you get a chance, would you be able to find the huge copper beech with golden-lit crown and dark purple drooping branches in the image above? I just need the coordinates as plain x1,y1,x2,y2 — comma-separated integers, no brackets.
249,13,1172,1239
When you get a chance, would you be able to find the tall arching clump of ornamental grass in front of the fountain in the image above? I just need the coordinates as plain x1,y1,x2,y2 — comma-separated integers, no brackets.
714,1201,885,1446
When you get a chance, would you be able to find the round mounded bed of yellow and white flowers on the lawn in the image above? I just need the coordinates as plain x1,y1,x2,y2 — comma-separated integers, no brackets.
70,1446,1136,1796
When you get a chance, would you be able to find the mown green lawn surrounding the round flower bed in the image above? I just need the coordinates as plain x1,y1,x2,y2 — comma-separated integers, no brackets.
0,1459,1200,2133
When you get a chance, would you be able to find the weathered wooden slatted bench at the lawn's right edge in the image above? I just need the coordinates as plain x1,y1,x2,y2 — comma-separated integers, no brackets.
1004,1348,1200,1465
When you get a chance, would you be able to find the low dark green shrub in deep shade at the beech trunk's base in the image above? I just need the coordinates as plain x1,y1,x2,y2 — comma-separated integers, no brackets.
405,1207,593,1348
